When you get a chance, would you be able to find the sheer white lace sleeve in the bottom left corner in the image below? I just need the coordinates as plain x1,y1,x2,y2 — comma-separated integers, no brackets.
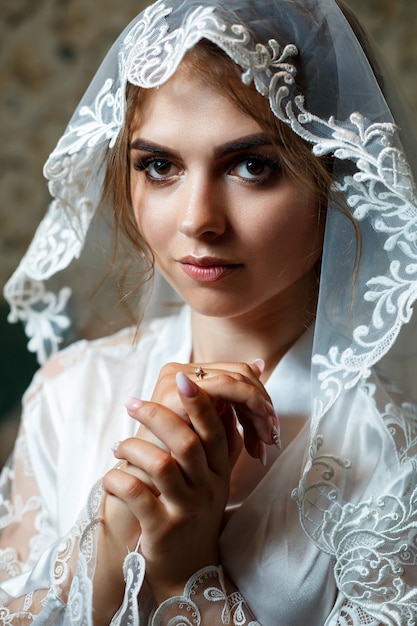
0,420,101,625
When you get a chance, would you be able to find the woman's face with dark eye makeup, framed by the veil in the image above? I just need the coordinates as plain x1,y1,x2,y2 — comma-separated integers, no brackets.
130,70,323,318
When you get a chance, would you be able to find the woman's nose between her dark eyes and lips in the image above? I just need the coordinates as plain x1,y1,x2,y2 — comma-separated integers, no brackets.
177,173,227,239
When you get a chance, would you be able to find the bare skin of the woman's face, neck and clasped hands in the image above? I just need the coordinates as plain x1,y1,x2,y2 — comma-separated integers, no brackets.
94,64,323,624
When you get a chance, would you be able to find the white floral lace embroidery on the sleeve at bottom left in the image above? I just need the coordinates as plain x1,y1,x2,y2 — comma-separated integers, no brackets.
0,446,102,626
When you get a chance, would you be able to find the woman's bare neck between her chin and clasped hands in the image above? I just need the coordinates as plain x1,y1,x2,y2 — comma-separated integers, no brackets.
191,272,317,380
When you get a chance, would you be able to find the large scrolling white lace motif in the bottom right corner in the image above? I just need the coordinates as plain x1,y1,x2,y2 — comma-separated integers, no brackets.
296,486,417,624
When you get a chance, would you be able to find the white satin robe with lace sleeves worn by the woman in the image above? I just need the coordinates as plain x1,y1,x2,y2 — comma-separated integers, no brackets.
0,307,417,626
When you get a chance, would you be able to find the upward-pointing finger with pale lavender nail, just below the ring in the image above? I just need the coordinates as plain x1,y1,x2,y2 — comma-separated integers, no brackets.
176,372,230,475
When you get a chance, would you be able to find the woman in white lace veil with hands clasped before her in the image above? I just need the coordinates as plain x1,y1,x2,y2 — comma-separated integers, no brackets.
0,0,417,626
